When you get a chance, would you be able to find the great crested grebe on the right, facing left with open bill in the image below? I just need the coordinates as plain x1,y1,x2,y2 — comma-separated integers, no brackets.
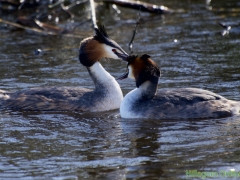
116,53,240,119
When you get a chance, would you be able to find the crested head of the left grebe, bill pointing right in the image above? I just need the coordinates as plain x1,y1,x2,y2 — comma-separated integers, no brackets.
79,26,128,67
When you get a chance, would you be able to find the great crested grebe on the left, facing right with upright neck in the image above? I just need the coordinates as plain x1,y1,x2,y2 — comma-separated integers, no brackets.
0,26,128,112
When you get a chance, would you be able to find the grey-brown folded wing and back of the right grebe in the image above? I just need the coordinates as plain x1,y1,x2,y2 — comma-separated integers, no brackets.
145,88,235,119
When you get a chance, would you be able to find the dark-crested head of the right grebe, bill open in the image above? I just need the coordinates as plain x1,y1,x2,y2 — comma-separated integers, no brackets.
118,54,160,87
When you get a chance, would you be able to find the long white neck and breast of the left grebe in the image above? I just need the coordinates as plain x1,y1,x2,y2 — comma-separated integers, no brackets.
87,62,123,110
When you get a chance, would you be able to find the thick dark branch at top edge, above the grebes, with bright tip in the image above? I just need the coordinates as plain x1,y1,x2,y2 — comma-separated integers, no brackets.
103,0,173,14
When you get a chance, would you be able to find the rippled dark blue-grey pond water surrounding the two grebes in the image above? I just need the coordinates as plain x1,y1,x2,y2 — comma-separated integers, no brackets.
0,0,240,180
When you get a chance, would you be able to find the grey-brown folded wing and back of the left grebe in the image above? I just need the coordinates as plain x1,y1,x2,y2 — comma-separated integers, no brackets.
4,87,92,111
